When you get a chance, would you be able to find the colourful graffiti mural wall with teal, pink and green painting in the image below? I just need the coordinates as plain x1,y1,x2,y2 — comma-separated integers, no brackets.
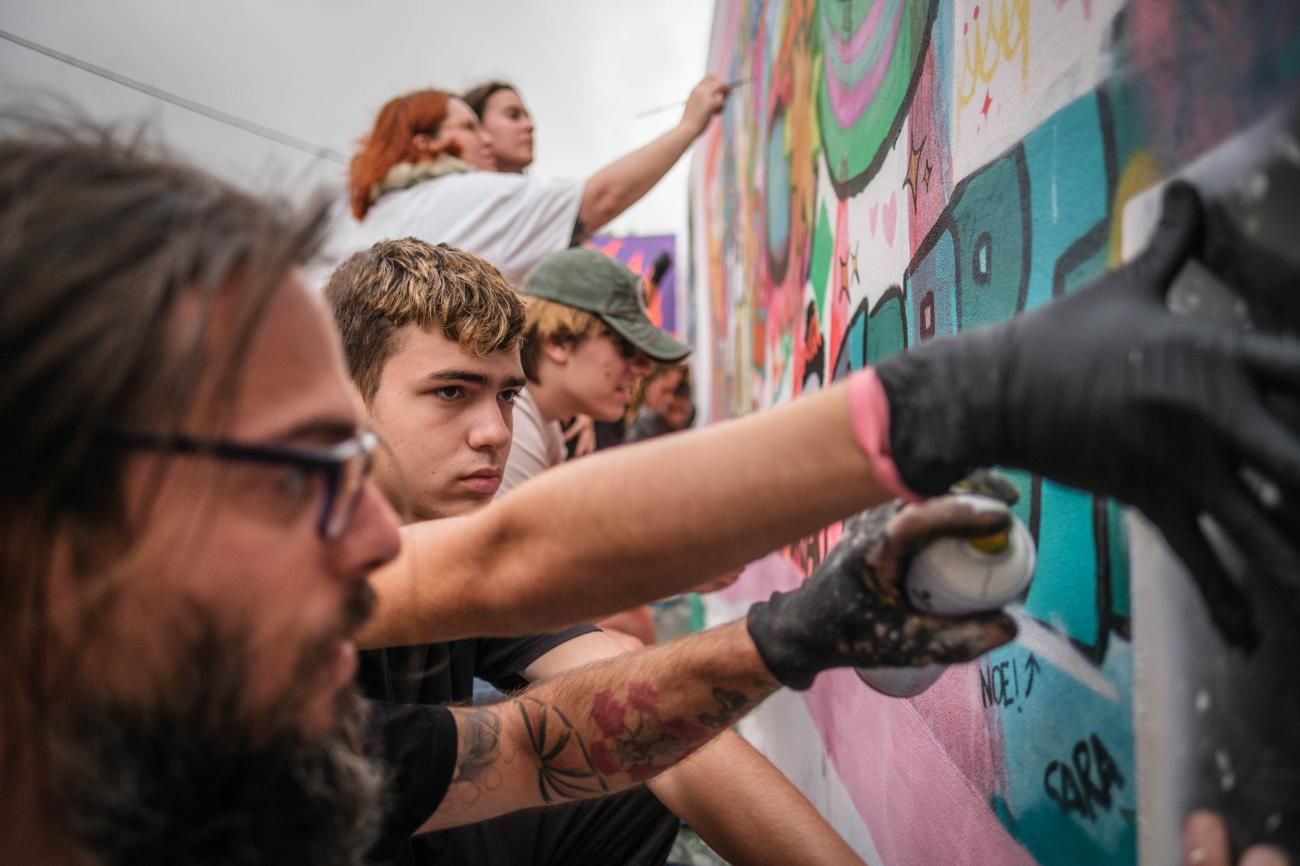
683,0,1300,866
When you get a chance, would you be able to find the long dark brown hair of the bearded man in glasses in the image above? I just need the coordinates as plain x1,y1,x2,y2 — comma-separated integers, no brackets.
0,114,325,781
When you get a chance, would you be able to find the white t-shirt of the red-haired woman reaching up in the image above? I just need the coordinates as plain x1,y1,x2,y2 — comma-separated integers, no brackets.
319,172,585,286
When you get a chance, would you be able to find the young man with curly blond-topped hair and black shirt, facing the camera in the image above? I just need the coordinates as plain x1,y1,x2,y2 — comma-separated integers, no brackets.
325,238,861,865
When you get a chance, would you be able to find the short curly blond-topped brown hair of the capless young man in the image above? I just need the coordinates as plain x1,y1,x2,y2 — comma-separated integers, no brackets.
325,238,524,403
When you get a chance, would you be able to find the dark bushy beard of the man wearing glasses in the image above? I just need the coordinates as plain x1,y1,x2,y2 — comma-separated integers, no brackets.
48,603,384,866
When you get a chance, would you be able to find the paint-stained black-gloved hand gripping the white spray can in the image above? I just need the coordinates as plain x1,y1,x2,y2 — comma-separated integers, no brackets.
748,497,1015,689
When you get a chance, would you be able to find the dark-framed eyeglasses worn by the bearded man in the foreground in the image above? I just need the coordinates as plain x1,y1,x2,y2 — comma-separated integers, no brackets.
109,430,380,541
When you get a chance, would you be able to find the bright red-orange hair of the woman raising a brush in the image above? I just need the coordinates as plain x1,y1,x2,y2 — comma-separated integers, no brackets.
347,90,460,220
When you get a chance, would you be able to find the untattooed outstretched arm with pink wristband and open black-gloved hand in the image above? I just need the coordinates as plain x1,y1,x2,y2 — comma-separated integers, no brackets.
360,186,1300,646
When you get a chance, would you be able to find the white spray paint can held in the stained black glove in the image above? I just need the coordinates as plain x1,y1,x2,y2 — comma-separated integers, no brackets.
857,494,1037,697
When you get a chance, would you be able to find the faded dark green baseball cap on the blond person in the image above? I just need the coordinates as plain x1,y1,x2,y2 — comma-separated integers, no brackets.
520,247,690,361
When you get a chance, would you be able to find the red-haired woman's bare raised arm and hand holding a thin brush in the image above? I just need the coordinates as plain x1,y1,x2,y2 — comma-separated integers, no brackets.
573,75,729,243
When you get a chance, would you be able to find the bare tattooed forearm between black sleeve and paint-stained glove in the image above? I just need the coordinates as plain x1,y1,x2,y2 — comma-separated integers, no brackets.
421,623,780,832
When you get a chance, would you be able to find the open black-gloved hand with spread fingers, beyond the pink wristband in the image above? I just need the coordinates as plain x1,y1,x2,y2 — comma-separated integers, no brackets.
876,183,1300,644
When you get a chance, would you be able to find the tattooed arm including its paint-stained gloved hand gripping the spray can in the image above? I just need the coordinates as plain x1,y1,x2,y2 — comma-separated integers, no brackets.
424,497,1015,832
